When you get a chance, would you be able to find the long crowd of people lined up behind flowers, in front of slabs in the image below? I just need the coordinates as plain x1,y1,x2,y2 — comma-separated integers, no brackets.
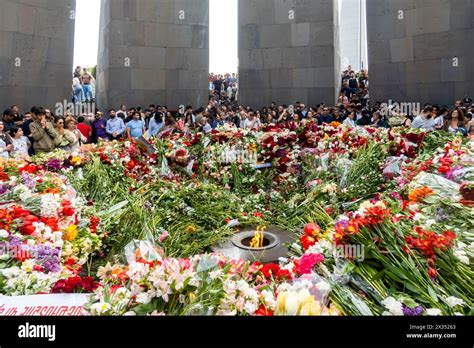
0,92,474,157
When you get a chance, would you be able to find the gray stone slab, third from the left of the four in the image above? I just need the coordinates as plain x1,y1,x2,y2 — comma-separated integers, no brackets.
239,0,340,107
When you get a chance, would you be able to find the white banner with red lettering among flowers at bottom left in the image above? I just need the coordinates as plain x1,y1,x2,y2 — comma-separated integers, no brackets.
0,294,89,316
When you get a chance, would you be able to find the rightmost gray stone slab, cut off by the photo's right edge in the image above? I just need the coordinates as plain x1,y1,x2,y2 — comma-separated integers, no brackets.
367,0,474,105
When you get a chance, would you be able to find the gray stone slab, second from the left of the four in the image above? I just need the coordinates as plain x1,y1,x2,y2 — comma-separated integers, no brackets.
97,0,209,109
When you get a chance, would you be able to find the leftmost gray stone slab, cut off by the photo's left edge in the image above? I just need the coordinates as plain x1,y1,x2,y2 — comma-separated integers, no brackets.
0,0,76,112
